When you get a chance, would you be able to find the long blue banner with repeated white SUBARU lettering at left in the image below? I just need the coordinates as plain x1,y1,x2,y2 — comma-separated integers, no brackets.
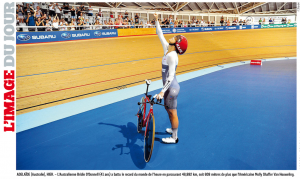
16,29,118,44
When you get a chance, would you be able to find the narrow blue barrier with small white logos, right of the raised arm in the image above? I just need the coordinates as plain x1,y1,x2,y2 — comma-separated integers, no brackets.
162,25,261,34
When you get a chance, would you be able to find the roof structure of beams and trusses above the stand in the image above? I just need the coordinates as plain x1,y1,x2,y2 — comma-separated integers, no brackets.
76,2,297,15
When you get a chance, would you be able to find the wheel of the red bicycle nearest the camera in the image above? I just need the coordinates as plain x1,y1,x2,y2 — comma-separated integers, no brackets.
144,114,155,162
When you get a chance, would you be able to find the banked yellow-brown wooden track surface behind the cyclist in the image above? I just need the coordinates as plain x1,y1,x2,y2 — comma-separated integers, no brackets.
17,28,297,115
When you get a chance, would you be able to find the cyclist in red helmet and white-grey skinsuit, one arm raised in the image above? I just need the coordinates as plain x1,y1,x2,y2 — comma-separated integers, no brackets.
154,13,188,143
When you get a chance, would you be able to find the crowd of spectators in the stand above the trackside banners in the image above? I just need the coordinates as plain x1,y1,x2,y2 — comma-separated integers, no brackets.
16,2,292,31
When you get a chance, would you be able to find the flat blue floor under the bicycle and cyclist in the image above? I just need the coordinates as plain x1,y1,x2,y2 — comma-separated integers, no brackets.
16,58,297,170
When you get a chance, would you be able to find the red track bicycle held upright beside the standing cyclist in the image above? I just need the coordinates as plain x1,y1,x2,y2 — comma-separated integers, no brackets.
137,80,165,162
